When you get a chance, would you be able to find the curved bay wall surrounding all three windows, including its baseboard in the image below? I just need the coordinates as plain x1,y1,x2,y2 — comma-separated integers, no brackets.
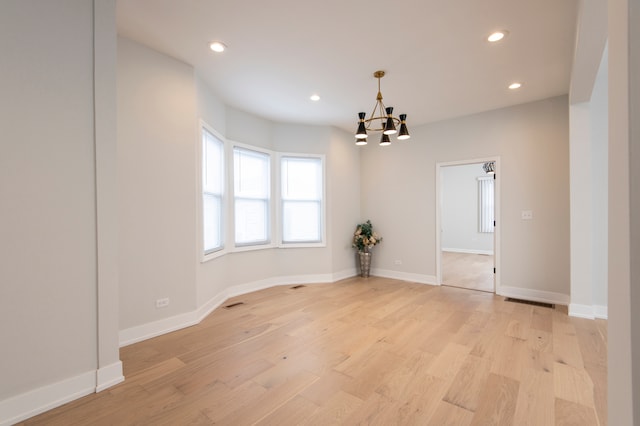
118,38,360,343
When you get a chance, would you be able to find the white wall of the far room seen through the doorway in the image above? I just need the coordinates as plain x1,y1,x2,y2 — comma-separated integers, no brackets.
440,164,493,254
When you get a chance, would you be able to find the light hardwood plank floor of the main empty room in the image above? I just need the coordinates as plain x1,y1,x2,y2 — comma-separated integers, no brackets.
24,277,607,426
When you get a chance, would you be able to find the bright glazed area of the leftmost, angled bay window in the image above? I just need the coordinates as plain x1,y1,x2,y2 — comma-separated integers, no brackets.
202,127,224,254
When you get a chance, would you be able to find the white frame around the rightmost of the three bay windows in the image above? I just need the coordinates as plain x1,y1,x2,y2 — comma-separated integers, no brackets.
276,152,327,248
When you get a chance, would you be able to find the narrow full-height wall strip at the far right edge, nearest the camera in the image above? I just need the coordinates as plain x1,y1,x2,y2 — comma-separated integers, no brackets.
608,0,640,426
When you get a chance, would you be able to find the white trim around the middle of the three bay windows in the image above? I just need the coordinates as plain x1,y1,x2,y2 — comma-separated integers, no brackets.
232,141,277,253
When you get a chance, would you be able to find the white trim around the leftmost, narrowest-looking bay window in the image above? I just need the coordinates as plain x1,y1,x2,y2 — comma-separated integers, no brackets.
202,120,229,263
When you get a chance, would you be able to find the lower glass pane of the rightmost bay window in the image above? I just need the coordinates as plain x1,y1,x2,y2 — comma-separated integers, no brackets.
282,201,322,242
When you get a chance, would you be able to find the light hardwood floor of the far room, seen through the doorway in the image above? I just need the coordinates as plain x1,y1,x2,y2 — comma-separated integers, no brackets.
442,251,495,293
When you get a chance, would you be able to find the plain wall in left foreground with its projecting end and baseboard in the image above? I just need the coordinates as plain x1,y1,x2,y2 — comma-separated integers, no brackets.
0,0,121,424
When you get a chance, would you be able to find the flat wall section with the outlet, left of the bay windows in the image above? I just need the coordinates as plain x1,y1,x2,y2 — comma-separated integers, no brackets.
118,38,198,329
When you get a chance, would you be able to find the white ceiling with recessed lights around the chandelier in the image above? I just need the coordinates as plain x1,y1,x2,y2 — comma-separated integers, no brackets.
117,0,578,132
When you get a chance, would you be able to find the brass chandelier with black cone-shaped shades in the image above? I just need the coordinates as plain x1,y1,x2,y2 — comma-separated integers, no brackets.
356,71,410,146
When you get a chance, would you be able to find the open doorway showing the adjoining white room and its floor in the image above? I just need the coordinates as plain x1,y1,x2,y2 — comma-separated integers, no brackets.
436,158,499,293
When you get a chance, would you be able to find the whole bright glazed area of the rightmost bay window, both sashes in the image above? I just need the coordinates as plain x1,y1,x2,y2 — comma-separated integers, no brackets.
280,156,324,244
